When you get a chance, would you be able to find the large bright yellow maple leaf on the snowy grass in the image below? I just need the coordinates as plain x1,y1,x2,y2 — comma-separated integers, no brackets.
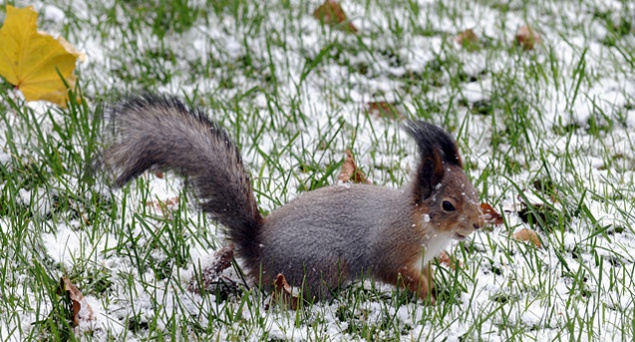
0,5,82,107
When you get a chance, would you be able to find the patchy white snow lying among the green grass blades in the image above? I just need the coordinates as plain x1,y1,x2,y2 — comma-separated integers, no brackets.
0,0,635,341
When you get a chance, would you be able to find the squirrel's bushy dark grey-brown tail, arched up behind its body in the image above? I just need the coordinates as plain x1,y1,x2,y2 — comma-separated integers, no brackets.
103,95,263,265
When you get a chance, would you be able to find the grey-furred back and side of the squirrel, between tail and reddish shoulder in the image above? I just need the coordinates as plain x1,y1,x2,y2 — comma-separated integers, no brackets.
262,184,414,299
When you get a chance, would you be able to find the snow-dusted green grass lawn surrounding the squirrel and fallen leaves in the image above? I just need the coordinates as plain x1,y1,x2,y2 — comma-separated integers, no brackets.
0,0,635,341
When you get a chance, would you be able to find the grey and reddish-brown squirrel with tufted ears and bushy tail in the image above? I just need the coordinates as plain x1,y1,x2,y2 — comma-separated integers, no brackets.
101,94,483,302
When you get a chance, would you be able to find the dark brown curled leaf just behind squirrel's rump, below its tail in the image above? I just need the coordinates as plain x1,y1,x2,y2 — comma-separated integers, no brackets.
187,246,238,299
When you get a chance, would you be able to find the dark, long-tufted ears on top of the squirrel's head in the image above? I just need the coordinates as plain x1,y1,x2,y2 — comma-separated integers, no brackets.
404,121,463,199
